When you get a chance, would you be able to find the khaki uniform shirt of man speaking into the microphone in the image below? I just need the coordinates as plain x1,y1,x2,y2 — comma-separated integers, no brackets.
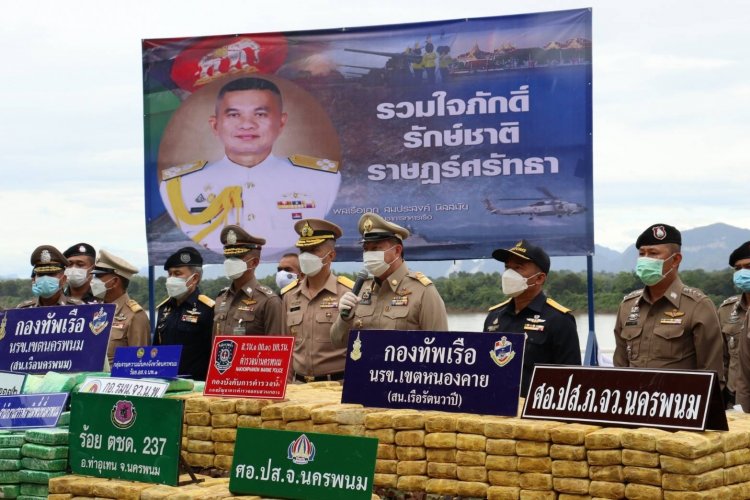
331,262,448,345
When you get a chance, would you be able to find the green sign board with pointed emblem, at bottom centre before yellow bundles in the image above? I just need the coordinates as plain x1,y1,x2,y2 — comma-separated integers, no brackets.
229,428,378,500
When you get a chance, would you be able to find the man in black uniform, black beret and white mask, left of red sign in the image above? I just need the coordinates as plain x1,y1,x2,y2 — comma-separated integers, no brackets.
154,247,214,380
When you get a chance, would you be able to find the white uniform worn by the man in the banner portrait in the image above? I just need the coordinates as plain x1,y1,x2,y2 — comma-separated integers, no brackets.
159,155,341,257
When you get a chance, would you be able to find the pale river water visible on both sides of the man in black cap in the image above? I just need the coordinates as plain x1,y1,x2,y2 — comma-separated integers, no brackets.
448,313,617,364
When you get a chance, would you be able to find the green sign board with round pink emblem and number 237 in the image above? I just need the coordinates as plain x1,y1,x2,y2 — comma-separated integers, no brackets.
70,393,183,486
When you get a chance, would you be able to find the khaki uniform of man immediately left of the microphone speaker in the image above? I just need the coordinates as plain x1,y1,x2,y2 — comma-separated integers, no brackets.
282,273,354,377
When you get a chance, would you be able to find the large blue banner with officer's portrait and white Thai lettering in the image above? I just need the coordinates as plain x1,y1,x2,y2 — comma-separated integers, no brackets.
143,9,594,265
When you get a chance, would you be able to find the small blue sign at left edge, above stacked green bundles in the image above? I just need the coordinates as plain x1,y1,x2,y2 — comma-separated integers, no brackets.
0,392,68,429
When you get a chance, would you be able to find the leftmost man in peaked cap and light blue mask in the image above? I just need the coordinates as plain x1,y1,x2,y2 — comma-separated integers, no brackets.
16,245,81,309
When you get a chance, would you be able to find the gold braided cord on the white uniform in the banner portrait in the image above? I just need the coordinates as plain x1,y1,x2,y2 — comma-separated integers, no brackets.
167,177,242,243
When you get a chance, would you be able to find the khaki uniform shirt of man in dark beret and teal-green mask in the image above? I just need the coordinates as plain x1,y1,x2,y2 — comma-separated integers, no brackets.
614,278,724,387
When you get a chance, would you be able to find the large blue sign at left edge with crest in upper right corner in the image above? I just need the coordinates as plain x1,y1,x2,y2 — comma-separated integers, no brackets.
0,304,115,373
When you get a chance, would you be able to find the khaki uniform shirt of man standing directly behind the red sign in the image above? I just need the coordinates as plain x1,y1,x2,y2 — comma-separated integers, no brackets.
213,277,286,337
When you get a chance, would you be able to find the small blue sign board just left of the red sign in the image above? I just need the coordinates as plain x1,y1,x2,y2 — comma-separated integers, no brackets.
112,345,182,378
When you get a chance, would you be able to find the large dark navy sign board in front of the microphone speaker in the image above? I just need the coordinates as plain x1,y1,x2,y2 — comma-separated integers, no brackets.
341,330,525,416
